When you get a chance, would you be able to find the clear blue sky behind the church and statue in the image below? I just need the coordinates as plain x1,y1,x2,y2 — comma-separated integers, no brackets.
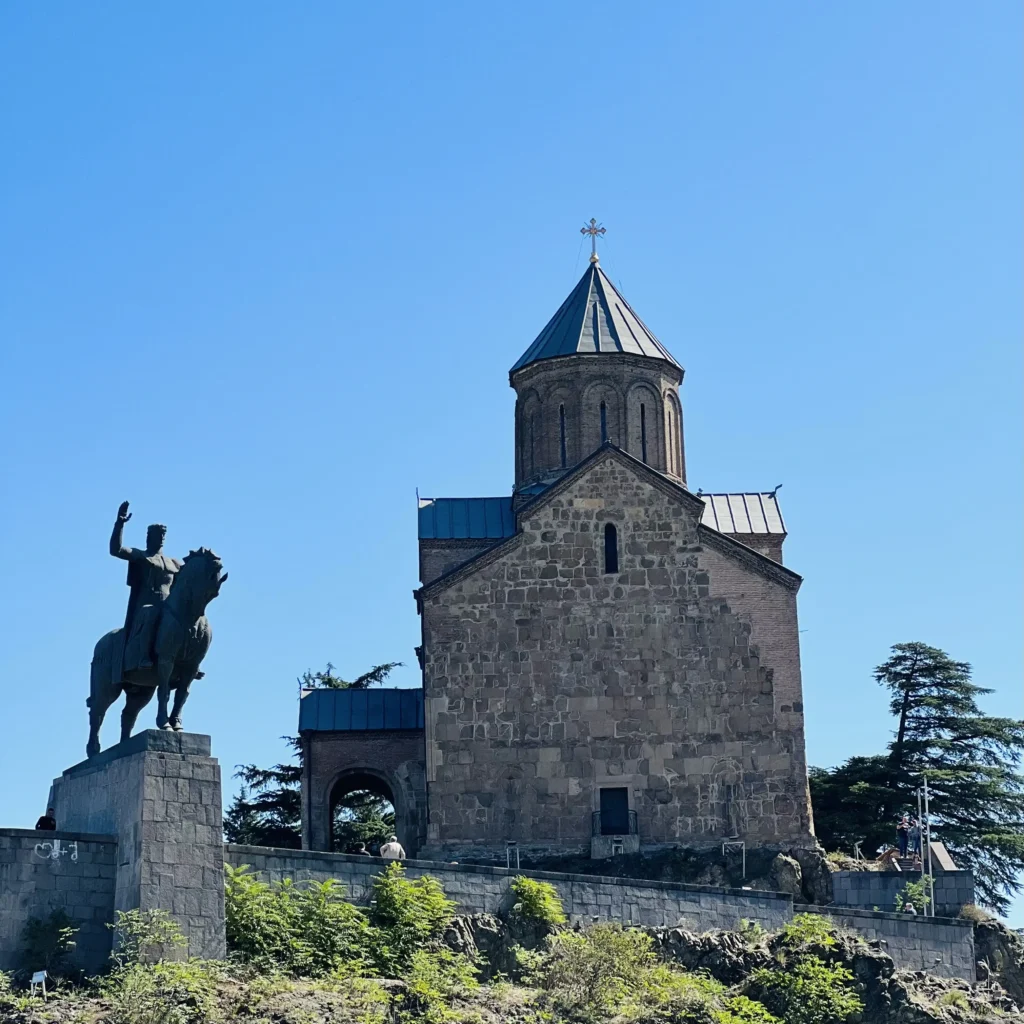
0,0,1024,925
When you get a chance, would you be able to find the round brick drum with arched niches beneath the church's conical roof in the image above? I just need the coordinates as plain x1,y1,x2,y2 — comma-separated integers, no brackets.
512,352,686,488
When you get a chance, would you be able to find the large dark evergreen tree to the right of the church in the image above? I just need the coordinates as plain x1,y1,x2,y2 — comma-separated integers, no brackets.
811,643,1024,912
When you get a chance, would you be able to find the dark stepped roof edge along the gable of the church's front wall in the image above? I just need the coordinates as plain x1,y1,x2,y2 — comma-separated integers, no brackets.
414,441,803,601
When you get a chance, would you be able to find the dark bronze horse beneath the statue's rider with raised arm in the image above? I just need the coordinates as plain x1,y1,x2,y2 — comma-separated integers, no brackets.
85,548,227,758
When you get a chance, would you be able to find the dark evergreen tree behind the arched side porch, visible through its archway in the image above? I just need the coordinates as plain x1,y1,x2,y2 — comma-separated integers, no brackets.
224,662,401,850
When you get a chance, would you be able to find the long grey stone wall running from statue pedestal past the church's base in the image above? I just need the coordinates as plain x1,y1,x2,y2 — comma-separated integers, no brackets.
224,846,793,931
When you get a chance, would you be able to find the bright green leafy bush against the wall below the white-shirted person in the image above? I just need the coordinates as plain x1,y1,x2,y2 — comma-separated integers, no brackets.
369,861,456,978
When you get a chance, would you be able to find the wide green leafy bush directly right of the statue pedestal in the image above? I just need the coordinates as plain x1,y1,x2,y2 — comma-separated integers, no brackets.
224,865,369,977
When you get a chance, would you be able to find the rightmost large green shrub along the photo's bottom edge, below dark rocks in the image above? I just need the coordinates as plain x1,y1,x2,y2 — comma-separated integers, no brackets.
750,954,864,1024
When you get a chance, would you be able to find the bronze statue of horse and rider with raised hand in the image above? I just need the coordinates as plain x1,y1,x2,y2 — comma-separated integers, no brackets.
85,502,227,758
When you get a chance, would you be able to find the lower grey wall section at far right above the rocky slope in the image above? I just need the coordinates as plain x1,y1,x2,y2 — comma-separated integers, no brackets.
795,905,976,981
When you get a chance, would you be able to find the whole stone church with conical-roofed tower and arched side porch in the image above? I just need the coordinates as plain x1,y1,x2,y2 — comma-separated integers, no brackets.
300,256,814,861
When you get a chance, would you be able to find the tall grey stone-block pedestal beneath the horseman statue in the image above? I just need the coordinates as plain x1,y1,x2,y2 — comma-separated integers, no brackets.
51,729,224,958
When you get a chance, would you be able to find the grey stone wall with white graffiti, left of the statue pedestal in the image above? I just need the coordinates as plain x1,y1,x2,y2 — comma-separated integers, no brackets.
0,828,118,973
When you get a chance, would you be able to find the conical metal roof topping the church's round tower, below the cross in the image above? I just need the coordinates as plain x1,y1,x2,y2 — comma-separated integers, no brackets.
510,261,682,374
